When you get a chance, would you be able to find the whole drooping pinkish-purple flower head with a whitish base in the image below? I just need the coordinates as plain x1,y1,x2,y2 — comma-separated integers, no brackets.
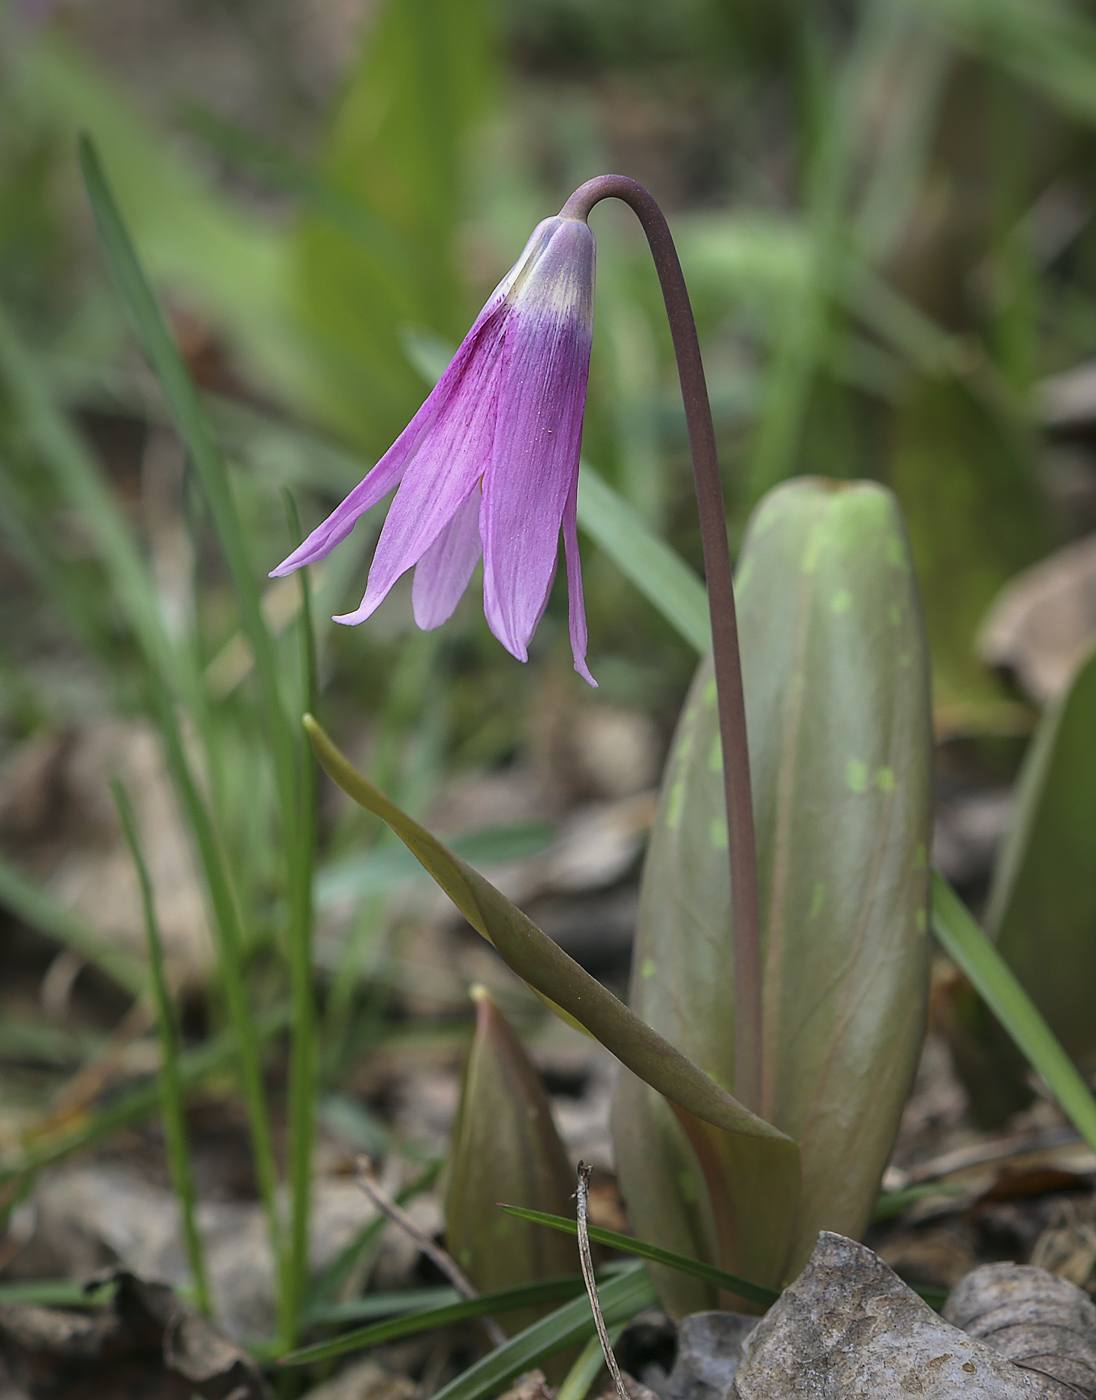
272,217,596,685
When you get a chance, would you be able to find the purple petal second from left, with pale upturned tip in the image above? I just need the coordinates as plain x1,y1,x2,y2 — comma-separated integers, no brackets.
335,320,512,624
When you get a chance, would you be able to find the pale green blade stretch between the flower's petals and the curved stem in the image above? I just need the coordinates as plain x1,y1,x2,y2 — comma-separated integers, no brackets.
578,462,711,654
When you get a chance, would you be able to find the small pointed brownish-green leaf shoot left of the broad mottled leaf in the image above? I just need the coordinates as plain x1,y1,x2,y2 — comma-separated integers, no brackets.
445,987,577,1334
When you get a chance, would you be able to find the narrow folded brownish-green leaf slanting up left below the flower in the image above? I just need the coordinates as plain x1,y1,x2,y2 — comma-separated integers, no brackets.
304,715,795,1163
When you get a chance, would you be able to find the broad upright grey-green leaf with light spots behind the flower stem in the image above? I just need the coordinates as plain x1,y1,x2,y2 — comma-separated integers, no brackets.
613,479,932,1312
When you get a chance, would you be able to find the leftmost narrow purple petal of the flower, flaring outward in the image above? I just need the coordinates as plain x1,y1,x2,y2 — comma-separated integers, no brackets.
270,295,508,578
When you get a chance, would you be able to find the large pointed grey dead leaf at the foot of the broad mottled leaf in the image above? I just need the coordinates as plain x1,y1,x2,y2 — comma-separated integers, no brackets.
729,1231,1052,1400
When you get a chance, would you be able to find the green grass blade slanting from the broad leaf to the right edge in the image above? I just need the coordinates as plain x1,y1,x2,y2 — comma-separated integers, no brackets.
932,874,1096,1152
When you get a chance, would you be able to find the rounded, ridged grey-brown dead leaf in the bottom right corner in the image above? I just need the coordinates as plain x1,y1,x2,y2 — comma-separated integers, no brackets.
943,1264,1096,1400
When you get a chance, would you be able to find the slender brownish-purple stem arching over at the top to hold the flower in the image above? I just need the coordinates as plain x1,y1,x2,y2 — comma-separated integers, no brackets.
560,175,761,1112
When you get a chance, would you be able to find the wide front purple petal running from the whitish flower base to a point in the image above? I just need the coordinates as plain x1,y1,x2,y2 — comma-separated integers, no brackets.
480,220,593,661
